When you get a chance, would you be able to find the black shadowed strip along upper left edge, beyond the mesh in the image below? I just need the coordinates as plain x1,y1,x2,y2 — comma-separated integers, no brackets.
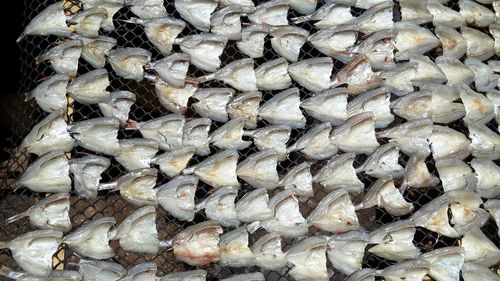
0,0,24,159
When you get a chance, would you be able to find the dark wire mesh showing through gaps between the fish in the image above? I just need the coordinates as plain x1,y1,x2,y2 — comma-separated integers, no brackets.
0,0,500,280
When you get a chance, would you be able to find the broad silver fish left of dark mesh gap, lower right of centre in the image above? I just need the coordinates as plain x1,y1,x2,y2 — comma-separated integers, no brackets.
307,189,360,233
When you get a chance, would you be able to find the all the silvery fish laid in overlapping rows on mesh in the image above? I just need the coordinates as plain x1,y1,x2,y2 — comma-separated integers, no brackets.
4,0,500,281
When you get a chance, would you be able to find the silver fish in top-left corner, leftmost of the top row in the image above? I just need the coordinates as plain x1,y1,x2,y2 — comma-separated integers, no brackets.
16,1,71,43
